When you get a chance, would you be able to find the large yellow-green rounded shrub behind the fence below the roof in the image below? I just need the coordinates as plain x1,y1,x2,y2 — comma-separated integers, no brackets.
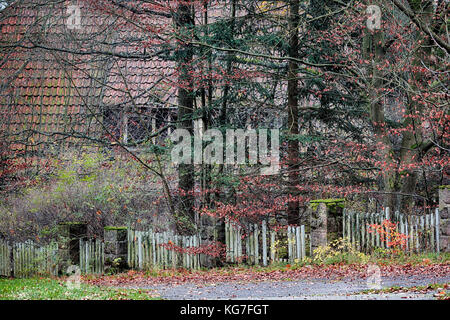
0,149,176,241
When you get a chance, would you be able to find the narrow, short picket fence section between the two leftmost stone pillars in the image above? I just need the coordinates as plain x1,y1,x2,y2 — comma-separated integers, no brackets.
79,239,105,274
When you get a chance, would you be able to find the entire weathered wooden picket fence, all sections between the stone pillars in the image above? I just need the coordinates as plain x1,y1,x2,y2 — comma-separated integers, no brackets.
4,208,439,277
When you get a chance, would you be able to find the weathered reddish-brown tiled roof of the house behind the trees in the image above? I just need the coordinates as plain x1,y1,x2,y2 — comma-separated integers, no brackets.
0,0,285,159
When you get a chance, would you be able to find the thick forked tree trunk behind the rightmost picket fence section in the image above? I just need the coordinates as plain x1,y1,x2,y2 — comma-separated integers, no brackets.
363,0,433,213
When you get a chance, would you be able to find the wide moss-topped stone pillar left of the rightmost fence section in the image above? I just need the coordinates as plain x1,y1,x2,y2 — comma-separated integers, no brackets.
309,199,345,251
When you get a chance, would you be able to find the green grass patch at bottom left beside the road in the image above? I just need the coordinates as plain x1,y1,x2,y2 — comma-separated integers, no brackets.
0,278,158,300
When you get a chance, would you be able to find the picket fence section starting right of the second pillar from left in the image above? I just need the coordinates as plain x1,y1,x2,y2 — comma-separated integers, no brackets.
128,229,201,270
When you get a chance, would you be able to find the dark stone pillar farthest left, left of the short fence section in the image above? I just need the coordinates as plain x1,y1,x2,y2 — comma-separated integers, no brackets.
58,222,87,274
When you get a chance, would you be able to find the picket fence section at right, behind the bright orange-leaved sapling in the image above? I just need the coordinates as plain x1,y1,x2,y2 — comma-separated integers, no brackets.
343,208,439,252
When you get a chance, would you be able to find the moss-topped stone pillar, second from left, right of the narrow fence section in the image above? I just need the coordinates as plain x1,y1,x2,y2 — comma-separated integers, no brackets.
104,227,128,272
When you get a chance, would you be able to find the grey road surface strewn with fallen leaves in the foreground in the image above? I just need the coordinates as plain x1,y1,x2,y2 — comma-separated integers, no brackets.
120,275,450,300
